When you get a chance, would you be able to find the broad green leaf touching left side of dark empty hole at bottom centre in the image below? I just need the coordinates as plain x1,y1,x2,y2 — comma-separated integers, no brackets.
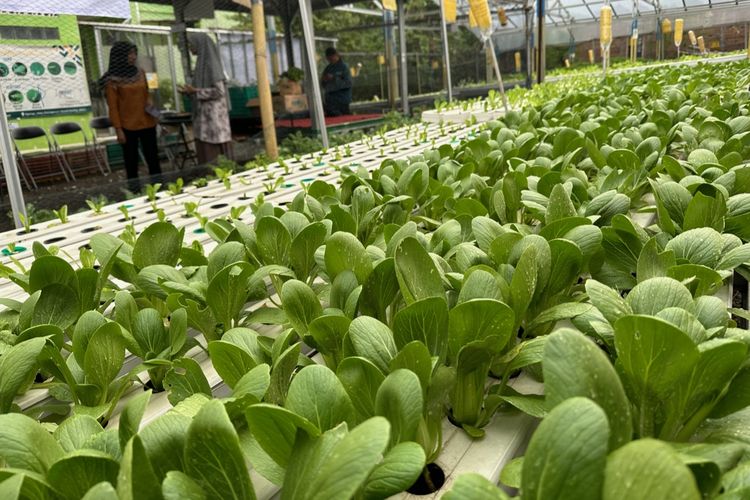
362,442,425,500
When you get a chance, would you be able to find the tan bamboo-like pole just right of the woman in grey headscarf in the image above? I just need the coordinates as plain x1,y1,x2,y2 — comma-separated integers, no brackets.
251,0,279,160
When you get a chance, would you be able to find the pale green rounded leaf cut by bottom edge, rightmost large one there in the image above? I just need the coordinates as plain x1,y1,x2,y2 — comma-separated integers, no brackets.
602,439,701,500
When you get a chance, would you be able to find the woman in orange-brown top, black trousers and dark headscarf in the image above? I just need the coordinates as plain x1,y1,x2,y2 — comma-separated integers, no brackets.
99,41,161,193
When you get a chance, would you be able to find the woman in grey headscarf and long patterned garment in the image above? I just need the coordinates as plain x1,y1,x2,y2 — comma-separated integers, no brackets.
180,33,232,165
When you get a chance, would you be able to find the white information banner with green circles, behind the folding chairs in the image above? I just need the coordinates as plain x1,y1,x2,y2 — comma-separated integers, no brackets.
0,45,91,118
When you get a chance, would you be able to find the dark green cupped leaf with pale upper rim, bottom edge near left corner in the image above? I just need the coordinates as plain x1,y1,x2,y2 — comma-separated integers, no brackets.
47,450,120,500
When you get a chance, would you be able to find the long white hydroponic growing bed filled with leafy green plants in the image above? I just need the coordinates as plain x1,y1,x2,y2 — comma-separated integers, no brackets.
0,55,750,499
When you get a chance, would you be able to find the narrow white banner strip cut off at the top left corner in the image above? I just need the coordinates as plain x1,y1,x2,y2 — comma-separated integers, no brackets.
0,0,130,19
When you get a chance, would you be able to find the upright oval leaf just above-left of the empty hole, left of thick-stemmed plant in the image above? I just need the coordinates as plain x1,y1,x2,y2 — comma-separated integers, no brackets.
375,369,423,446
